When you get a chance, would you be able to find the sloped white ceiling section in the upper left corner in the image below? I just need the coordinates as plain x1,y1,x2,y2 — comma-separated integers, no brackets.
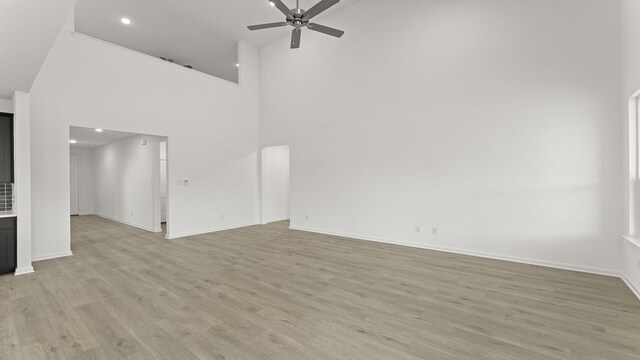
0,0,74,99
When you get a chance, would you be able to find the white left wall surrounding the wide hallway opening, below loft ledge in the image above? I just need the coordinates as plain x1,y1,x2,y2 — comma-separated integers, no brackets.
31,11,259,256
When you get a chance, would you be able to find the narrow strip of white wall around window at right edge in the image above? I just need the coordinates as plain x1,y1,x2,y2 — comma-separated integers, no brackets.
620,0,640,297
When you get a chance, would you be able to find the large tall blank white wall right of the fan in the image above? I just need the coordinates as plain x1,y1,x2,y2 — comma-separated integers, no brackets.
260,0,620,273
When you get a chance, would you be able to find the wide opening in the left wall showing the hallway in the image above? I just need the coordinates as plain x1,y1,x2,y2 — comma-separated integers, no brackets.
69,126,169,233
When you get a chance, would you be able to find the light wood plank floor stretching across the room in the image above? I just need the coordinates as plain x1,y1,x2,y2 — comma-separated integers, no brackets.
0,216,640,360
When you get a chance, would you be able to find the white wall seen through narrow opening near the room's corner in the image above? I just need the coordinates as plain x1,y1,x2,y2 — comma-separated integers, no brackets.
262,145,289,224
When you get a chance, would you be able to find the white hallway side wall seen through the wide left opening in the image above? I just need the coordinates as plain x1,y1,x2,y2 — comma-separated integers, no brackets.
93,135,164,231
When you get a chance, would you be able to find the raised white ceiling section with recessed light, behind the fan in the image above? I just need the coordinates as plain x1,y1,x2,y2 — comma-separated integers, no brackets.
74,0,359,82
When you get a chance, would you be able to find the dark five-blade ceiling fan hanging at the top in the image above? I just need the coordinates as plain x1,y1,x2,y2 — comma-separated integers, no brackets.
247,0,344,49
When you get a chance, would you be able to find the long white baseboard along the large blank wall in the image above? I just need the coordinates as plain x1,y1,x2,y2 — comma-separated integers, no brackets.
289,226,620,277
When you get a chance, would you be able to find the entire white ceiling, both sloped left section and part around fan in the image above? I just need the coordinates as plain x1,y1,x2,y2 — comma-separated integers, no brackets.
0,0,360,99
